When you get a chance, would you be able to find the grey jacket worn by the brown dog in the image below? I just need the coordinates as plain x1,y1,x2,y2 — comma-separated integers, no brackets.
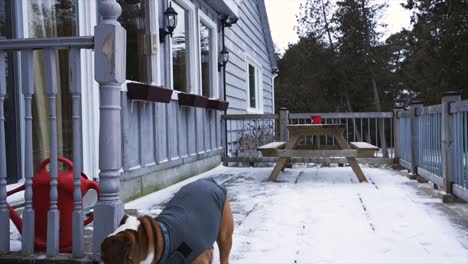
156,178,226,264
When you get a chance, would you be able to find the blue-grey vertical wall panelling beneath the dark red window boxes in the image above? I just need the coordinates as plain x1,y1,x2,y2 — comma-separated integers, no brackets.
122,97,222,182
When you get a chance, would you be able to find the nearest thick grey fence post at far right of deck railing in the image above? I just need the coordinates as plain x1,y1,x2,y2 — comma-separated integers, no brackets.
441,91,461,202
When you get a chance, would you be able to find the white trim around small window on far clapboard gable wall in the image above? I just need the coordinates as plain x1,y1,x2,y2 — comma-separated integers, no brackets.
245,54,263,114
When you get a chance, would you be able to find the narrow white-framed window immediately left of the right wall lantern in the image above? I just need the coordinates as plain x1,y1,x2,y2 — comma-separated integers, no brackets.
199,13,219,98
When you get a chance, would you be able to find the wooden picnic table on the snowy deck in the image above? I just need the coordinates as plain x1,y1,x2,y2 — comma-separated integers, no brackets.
259,124,376,182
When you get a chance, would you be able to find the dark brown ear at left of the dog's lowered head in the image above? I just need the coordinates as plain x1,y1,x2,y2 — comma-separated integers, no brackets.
101,236,131,264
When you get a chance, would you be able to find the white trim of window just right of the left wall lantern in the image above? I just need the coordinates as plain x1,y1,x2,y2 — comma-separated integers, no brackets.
169,0,199,96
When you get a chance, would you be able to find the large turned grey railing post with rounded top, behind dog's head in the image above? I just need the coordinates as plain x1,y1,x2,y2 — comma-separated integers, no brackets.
93,0,127,260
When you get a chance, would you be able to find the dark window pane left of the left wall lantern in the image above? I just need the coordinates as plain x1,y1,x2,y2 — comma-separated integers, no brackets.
117,0,149,83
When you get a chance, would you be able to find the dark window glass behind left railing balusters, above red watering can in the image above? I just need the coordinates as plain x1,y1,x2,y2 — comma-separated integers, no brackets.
27,0,79,171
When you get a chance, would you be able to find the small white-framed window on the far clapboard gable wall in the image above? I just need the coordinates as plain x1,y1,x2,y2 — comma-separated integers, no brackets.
246,57,263,112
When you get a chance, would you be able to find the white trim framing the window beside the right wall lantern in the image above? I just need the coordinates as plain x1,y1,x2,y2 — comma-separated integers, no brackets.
197,10,220,99
